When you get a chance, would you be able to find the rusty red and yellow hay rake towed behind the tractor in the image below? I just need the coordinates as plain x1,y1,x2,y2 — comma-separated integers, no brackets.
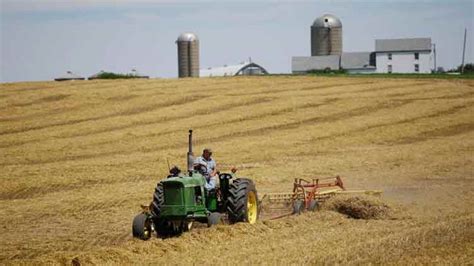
259,176,382,220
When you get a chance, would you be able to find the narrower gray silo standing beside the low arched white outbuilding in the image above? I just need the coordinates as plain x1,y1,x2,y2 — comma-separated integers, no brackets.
176,32,199,78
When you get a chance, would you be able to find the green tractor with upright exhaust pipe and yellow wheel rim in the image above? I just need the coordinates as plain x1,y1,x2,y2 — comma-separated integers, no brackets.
132,130,259,240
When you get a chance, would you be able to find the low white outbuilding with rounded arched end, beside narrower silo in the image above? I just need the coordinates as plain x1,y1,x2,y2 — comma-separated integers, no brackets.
199,62,268,77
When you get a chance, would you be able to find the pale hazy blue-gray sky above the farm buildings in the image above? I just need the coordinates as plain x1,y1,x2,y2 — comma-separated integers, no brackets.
0,0,474,82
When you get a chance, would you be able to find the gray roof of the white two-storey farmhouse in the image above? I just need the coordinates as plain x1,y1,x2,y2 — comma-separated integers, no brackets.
375,38,431,52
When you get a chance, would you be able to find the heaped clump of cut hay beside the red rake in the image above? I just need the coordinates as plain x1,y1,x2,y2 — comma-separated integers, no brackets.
323,196,392,220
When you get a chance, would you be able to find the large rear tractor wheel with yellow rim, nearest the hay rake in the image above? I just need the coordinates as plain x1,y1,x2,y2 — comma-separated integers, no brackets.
227,178,259,223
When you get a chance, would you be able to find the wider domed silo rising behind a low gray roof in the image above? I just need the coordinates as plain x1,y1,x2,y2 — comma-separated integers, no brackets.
311,14,342,56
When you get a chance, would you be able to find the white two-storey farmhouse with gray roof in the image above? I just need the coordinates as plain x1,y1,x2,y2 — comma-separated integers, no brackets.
375,38,431,73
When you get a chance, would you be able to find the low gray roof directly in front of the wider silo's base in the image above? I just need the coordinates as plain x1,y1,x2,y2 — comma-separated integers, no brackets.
291,55,340,72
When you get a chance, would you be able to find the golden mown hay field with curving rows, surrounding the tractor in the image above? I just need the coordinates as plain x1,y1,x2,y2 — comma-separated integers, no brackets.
0,76,474,264
